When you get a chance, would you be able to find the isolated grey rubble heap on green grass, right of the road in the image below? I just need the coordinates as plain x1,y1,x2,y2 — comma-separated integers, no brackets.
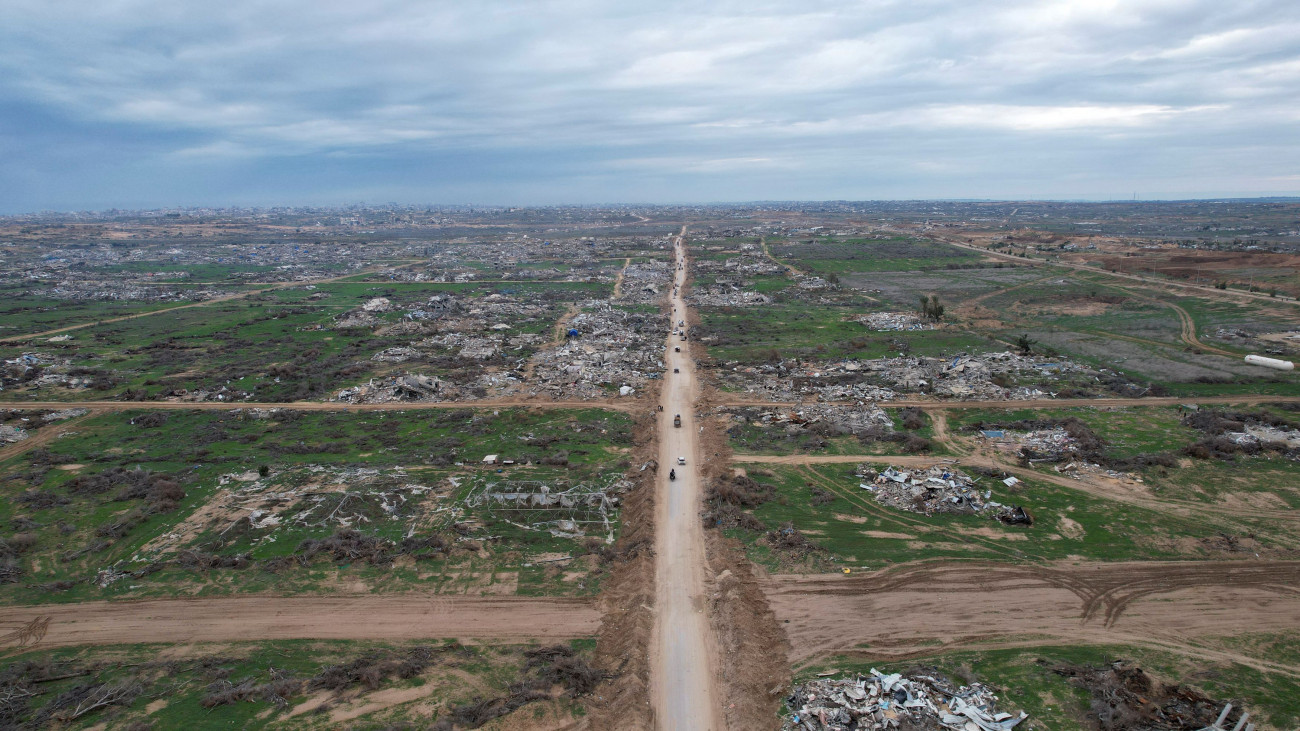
861,464,1034,525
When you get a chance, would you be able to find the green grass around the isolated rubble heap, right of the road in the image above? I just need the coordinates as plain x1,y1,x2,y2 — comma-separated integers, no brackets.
729,464,1292,571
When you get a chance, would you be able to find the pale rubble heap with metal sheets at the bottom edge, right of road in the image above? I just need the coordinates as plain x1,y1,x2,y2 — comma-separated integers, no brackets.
781,667,1028,731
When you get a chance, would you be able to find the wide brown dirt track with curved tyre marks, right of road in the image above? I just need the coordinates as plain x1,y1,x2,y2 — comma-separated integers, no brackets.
763,561,1300,676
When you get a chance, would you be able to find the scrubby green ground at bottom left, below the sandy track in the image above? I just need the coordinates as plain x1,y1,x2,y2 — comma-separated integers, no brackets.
0,640,592,728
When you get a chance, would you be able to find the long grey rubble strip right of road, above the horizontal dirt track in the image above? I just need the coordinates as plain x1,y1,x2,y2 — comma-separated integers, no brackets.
719,352,1095,402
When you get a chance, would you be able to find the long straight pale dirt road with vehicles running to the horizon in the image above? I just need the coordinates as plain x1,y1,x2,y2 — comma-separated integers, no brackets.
650,228,723,731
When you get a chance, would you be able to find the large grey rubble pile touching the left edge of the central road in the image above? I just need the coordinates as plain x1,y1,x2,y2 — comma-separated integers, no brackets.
514,300,668,401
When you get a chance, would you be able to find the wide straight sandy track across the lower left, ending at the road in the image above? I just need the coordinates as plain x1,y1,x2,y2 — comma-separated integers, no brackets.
0,594,601,648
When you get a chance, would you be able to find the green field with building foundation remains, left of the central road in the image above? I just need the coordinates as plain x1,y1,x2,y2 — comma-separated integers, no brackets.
0,408,632,604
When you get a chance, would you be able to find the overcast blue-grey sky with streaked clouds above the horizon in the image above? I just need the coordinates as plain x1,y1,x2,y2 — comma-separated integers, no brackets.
0,0,1300,212
